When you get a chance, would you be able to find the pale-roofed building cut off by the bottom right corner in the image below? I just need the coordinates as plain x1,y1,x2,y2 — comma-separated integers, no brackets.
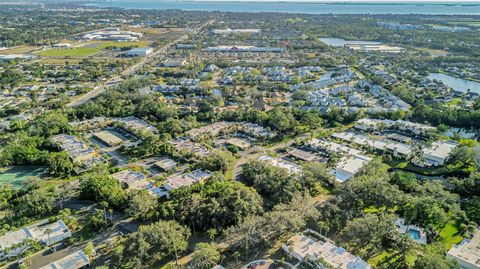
447,230,480,269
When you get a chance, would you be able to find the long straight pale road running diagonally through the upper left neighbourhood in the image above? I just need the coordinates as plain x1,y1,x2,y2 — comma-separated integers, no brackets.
67,20,213,107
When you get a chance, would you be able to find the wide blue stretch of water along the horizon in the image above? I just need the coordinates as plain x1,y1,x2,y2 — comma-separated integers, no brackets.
87,0,480,15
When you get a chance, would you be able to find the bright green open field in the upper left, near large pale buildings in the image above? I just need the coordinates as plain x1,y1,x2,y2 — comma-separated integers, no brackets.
37,41,150,57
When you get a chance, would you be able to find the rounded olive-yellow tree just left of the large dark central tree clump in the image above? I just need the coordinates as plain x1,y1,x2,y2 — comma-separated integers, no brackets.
125,190,158,220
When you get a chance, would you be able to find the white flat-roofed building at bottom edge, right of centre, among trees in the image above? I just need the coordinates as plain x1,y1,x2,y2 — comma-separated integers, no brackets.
282,230,371,269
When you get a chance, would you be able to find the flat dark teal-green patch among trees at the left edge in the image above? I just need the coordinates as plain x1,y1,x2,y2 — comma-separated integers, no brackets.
0,166,46,188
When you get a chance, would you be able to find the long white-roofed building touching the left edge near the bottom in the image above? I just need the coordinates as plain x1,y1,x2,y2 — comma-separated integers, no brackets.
0,220,72,260
